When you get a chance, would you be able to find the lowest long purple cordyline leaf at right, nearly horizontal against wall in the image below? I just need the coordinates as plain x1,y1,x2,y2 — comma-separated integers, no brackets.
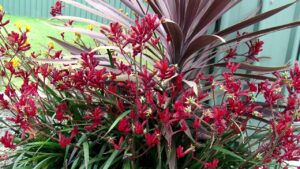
214,63,290,72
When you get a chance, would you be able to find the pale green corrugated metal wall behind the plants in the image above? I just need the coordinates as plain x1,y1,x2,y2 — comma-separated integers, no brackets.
0,0,300,63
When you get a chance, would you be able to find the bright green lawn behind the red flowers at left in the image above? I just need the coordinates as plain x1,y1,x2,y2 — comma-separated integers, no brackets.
5,15,93,52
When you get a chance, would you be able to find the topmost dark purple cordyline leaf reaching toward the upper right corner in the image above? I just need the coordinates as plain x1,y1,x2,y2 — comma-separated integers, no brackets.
216,0,298,36
